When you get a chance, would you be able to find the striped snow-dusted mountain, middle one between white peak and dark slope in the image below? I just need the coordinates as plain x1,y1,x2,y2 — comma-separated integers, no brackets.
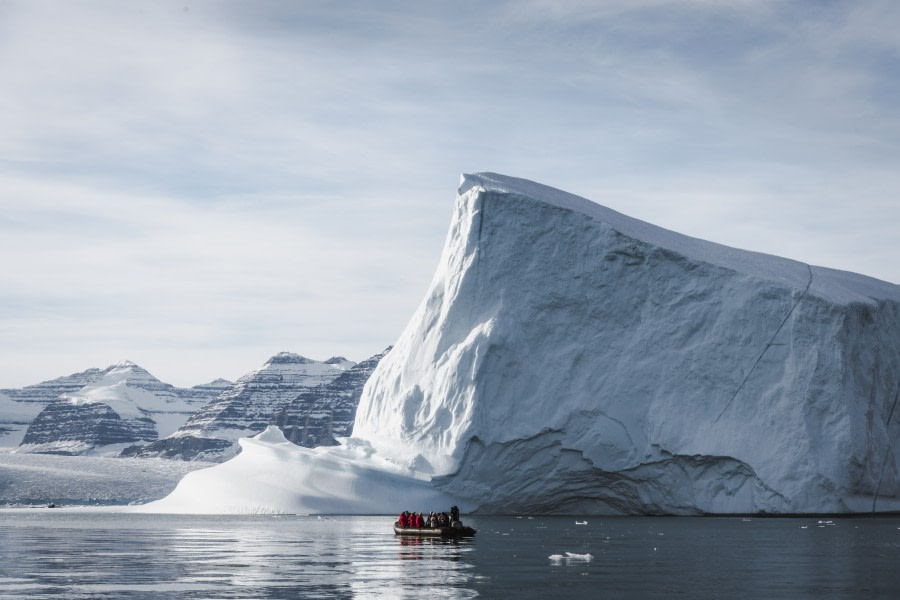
123,352,355,461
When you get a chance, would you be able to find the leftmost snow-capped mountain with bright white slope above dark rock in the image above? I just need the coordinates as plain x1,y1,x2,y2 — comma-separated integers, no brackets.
18,361,230,454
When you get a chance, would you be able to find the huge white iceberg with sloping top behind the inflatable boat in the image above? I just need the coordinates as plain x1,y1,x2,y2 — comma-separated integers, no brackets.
146,173,900,515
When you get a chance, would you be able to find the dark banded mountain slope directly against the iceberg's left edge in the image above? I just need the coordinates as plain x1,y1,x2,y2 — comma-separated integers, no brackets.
273,348,390,448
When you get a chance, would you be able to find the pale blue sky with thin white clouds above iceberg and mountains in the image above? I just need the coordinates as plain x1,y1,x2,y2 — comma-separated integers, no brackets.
0,0,900,388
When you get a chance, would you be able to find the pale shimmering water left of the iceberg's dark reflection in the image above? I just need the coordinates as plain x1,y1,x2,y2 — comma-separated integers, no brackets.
0,513,477,598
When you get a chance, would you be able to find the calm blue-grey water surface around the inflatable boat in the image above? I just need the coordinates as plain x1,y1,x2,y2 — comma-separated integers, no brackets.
0,510,900,600
